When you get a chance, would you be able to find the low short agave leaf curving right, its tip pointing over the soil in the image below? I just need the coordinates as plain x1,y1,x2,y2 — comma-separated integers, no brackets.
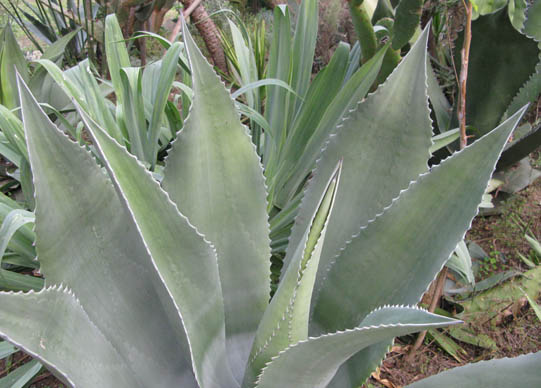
257,307,460,388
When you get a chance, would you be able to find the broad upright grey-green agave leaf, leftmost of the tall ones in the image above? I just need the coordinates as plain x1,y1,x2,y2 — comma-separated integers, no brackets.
20,77,196,387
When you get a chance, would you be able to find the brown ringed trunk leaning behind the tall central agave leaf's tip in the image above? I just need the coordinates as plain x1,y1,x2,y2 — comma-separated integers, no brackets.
181,0,227,74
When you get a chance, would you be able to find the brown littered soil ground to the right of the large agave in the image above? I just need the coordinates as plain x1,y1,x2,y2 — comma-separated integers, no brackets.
365,151,541,388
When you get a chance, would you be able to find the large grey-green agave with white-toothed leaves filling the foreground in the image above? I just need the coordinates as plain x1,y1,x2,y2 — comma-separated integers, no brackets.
0,8,540,388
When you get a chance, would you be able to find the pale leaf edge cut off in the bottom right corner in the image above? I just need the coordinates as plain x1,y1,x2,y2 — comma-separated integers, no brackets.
407,352,541,388
